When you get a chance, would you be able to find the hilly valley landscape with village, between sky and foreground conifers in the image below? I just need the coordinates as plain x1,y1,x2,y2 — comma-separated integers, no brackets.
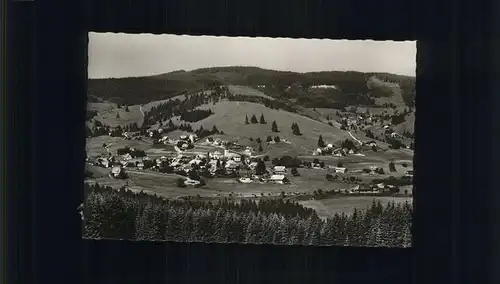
85,67,415,218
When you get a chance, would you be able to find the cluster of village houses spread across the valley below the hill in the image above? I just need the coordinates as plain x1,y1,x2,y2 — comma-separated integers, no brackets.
87,122,413,200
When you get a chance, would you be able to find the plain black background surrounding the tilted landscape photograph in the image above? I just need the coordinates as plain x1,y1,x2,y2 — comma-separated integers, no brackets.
2,0,500,284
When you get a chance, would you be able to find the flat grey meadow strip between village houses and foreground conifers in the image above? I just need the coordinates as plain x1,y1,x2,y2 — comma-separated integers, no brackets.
87,163,412,217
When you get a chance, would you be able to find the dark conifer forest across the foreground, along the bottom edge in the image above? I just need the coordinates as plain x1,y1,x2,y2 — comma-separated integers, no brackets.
83,185,413,247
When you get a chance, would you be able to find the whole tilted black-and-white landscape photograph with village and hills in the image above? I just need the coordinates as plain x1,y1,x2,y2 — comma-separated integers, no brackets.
84,33,417,247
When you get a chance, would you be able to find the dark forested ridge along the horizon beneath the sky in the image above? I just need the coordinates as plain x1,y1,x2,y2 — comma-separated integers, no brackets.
88,66,415,105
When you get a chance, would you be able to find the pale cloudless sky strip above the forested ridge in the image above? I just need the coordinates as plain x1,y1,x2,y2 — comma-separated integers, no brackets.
88,33,417,78
